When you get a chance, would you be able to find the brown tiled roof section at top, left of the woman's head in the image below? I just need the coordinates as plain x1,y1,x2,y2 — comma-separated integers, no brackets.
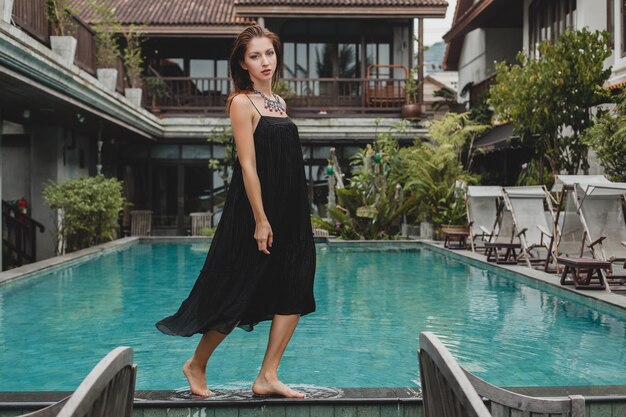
72,0,255,26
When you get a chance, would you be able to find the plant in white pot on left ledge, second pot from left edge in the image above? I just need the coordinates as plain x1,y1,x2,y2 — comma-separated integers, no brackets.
46,0,78,66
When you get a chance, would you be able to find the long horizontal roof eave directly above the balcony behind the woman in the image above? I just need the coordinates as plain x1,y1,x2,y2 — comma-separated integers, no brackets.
235,6,448,19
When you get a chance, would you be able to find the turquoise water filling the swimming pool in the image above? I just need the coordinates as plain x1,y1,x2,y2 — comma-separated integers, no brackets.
0,243,626,391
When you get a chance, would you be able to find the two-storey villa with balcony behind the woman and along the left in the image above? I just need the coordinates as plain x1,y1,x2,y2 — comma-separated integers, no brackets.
0,0,447,264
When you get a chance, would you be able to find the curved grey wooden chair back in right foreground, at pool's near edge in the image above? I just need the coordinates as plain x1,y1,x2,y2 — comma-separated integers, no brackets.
419,332,585,417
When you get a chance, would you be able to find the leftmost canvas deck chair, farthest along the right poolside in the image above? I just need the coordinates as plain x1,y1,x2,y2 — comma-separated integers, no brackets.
465,185,502,252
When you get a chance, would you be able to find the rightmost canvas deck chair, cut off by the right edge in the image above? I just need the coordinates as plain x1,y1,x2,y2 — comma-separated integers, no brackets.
574,182,626,291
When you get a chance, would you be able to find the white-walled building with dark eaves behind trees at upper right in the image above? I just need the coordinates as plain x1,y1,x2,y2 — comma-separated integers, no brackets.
444,0,626,184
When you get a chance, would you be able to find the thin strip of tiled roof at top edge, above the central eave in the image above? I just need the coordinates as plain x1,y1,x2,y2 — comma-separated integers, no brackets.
234,0,448,7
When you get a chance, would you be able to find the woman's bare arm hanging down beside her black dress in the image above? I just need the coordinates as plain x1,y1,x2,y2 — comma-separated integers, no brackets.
230,94,274,254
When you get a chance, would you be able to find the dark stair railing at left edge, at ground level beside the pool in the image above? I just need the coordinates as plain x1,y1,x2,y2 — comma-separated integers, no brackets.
2,201,44,270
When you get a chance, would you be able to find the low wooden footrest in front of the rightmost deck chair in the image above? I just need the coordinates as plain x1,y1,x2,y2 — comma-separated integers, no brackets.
556,256,611,290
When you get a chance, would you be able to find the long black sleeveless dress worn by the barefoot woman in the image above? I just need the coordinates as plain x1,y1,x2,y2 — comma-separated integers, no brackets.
156,110,315,336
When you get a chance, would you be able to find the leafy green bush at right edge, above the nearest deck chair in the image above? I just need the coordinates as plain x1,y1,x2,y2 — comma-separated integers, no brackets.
582,96,626,182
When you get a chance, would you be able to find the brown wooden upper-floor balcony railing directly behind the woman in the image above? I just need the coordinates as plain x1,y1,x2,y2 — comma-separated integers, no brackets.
145,76,406,113
